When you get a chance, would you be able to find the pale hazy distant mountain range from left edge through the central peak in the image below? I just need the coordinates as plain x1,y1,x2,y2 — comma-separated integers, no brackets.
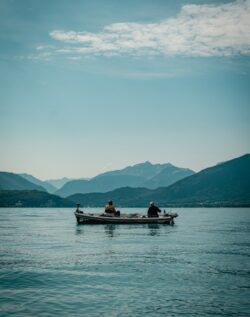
0,162,194,197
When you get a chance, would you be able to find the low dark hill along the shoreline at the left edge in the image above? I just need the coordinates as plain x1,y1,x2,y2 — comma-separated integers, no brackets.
0,190,75,207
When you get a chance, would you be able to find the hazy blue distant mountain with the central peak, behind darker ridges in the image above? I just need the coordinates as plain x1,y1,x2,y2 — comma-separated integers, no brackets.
56,162,194,197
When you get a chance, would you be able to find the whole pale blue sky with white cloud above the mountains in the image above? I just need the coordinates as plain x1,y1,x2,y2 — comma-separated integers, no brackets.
0,0,250,180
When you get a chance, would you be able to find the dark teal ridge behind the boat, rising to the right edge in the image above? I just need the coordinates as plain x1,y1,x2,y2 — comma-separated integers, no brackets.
67,154,250,207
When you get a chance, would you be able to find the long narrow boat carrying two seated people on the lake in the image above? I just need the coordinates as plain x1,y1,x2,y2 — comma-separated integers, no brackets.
75,209,178,224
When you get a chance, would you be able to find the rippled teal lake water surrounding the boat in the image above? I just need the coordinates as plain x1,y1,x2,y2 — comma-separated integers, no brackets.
0,208,250,317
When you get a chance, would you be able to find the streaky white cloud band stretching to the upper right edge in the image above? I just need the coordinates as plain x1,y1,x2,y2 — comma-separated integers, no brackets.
47,0,250,56
